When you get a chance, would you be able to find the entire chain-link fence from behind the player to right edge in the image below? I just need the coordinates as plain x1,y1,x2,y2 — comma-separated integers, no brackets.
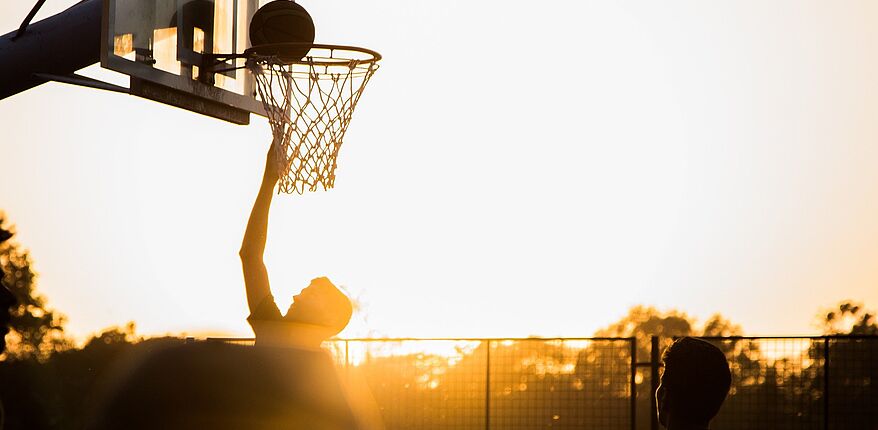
203,336,878,430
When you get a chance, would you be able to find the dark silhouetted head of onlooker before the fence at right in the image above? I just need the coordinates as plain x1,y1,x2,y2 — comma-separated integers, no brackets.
655,337,732,430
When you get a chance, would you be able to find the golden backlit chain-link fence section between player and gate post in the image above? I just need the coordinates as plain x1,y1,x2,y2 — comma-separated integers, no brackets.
330,339,634,430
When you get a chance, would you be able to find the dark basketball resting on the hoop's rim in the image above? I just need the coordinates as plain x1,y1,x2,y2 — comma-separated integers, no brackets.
250,0,314,62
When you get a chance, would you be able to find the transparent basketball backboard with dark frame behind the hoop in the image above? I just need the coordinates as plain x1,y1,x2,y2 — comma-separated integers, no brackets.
101,0,265,124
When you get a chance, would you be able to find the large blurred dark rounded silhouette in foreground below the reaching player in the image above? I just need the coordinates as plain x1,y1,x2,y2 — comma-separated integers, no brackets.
86,342,357,430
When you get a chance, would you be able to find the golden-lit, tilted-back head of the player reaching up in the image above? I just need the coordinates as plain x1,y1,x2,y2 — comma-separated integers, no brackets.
284,277,353,338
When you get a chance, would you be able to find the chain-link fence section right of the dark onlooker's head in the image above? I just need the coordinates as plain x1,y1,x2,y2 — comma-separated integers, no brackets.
705,336,878,430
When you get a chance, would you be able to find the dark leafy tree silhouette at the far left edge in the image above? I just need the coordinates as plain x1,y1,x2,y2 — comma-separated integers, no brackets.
0,213,71,360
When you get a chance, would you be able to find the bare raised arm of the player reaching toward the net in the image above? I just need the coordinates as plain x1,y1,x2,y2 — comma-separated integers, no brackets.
239,147,278,312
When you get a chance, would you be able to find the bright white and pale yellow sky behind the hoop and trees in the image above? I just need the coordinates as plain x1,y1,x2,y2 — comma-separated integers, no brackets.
0,0,878,342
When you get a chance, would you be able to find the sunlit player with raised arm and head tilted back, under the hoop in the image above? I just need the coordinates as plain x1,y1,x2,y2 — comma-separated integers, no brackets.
240,145,353,349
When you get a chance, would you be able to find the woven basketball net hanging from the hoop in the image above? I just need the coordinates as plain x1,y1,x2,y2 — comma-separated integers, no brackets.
247,49,378,194
